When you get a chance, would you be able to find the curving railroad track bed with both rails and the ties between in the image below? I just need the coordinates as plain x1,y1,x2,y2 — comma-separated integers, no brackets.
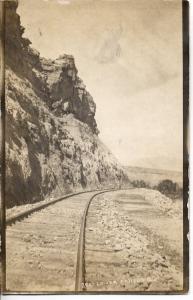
6,189,128,291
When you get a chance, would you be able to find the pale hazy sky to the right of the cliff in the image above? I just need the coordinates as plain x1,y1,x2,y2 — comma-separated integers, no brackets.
18,0,183,171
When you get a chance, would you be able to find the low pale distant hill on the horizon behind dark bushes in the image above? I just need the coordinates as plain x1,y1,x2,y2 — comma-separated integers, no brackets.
125,166,183,187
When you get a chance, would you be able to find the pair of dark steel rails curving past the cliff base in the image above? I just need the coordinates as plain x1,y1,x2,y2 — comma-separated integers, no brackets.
6,188,132,292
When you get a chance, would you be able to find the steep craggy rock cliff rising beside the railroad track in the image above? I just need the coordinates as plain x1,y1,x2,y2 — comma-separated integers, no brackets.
5,1,128,207
